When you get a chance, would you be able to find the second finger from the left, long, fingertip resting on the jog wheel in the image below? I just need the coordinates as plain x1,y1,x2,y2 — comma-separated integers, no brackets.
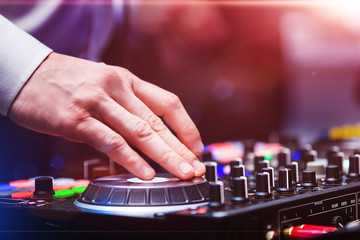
92,97,194,179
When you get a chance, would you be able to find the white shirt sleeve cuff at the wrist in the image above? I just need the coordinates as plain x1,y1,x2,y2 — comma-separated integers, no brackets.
0,15,52,115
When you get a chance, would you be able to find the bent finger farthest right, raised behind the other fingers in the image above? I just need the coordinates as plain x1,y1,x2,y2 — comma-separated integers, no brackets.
133,79,204,155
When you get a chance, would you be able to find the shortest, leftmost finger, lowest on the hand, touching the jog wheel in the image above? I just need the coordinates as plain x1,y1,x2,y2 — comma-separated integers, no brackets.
75,117,155,180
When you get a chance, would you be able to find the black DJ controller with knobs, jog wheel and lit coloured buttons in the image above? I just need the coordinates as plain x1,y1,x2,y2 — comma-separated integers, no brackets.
0,141,360,240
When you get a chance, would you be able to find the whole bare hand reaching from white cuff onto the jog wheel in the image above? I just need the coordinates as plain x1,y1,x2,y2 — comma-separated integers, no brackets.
8,53,205,180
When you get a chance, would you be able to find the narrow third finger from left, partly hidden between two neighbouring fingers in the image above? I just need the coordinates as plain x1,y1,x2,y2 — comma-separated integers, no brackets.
109,93,205,176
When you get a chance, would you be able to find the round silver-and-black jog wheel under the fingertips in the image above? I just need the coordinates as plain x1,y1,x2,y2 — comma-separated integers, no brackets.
75,173,209,217
